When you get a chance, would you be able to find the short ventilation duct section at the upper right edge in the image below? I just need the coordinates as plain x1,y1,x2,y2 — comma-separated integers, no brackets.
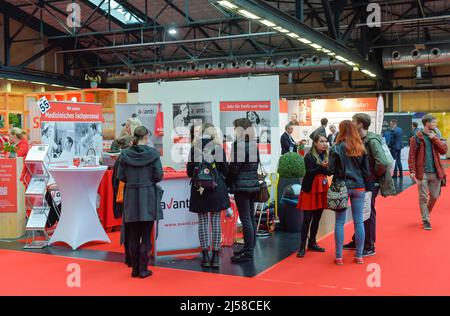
383,45,450,69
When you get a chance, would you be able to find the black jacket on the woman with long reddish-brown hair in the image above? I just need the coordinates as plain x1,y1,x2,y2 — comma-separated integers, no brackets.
328,142,370,189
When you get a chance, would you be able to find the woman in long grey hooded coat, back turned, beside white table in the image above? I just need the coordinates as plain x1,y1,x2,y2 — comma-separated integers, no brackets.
118,126,163,278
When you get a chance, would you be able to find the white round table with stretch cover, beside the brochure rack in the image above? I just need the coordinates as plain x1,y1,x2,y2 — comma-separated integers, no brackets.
49,166,111,250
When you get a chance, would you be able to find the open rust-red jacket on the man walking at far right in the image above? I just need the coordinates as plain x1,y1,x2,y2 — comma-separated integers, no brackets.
408,131,447,180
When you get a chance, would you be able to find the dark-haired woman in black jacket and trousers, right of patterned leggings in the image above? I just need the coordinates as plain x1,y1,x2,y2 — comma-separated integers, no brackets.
227,118,260,263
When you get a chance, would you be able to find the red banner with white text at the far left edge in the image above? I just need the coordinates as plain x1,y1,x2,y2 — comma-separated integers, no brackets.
0,159,17,213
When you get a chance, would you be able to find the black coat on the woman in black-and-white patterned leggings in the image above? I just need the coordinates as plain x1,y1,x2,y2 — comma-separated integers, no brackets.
187,139,230,213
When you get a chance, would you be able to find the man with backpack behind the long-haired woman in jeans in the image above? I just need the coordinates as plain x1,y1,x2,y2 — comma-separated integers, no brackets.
344,113,396,257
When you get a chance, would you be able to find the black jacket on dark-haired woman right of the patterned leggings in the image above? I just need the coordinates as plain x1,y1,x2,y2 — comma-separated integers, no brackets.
227,141,260,193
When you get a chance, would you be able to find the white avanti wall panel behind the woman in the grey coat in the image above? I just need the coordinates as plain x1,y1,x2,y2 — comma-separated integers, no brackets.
115,103,163,156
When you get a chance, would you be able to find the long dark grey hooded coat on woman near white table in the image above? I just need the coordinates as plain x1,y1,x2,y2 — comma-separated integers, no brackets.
118,145,163,223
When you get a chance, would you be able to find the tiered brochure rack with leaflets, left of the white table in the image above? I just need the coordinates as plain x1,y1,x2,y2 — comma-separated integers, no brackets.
24,145,50,249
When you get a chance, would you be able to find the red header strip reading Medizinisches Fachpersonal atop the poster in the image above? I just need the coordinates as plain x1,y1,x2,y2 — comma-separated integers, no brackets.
41,101,103,123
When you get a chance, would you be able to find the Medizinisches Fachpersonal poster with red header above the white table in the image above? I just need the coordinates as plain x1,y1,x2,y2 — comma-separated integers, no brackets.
40,101,103,165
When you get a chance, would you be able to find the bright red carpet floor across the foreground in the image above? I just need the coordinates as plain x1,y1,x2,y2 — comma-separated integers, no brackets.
0,180,450,296
